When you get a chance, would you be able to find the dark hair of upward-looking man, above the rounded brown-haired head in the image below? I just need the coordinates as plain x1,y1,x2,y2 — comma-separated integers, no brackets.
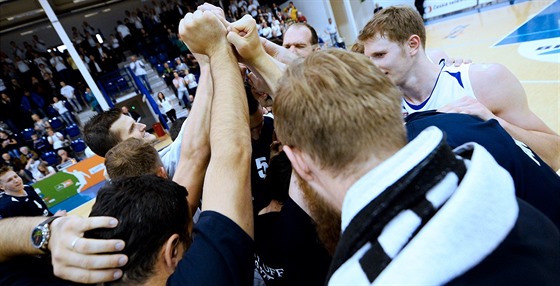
84,108,122,157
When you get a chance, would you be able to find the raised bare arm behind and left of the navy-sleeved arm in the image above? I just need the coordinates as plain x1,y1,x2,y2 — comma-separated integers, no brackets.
173,54,213,212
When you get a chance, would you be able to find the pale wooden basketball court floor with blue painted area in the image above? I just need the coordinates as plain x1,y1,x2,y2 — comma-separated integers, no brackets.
70,0,560,216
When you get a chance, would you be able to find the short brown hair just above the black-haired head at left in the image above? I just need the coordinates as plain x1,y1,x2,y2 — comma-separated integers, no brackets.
105,138,162,180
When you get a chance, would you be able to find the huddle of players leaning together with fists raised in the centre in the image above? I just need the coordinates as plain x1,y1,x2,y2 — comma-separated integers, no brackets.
0,4,560,285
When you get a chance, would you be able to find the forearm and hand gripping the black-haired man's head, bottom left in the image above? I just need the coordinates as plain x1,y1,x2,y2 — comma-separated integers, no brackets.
0,216,128,283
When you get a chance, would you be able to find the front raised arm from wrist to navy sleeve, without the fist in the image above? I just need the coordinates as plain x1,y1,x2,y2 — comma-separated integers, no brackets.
202,48,253,237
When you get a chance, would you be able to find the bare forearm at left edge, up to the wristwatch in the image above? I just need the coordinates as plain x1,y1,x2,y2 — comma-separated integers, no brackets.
0,217,46,262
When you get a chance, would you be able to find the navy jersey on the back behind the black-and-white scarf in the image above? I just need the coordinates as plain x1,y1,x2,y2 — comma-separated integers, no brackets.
406,111,560,228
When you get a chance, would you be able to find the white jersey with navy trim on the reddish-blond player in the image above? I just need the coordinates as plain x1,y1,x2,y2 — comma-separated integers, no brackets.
402,64,476,117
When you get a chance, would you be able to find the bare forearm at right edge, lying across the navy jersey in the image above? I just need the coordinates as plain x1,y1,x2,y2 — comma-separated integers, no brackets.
497,118,560,171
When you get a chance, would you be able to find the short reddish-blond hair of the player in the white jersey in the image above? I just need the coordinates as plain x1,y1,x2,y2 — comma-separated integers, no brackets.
358,6,426,48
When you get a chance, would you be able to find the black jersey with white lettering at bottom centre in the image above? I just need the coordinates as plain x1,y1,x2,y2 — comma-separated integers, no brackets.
255,198,331,285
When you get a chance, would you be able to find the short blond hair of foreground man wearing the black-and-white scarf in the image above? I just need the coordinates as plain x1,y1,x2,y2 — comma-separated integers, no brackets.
273,49,406,173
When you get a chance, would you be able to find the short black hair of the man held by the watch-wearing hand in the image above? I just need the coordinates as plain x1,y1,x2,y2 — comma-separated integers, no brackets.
85,175,192,284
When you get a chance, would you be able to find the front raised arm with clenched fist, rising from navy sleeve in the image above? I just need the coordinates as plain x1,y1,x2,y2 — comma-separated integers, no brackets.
180,10,253,237
